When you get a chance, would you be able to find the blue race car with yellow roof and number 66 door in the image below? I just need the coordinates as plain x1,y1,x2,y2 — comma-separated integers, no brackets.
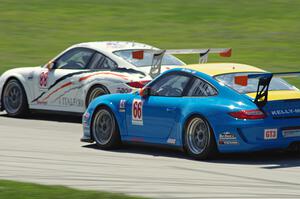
81,64,300,159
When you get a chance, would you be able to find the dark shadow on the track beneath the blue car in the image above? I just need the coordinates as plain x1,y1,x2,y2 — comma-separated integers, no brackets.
83,144,300,169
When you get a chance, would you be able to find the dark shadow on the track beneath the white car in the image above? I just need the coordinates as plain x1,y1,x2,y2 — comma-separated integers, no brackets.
0,112,82,123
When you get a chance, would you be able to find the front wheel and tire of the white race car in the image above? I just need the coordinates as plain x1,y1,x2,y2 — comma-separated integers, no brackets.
2,79,28,117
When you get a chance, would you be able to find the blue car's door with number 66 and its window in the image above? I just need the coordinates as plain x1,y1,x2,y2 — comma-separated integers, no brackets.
126,73,191,139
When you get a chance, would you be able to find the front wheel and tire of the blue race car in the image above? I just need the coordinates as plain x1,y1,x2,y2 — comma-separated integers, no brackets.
91,106,121,150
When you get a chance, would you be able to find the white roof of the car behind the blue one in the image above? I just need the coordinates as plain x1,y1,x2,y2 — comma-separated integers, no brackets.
72,41,157,54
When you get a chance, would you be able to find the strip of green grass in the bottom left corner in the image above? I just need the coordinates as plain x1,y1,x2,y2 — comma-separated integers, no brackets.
0,180,146,199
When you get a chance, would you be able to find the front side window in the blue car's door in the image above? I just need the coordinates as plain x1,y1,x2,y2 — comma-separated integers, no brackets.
151,73,191,97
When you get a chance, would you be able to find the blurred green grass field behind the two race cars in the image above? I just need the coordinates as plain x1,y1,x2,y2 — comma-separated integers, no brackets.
0,0,300,86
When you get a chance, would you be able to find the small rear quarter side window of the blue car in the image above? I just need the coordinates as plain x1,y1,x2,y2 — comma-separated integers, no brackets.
187,78,218,96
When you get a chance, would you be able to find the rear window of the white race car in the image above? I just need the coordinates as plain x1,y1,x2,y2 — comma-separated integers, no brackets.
114,49,184,67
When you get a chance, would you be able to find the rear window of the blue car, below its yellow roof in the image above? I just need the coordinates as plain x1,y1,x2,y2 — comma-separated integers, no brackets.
215,73,297,93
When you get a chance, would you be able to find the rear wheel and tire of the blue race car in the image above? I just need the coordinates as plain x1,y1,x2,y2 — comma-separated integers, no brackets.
184,116,217,160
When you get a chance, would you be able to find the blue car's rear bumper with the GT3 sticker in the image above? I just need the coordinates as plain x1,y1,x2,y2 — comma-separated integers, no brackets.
215,118,300,153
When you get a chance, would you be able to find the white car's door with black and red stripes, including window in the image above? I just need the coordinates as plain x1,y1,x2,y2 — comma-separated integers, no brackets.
31,48,95,112
